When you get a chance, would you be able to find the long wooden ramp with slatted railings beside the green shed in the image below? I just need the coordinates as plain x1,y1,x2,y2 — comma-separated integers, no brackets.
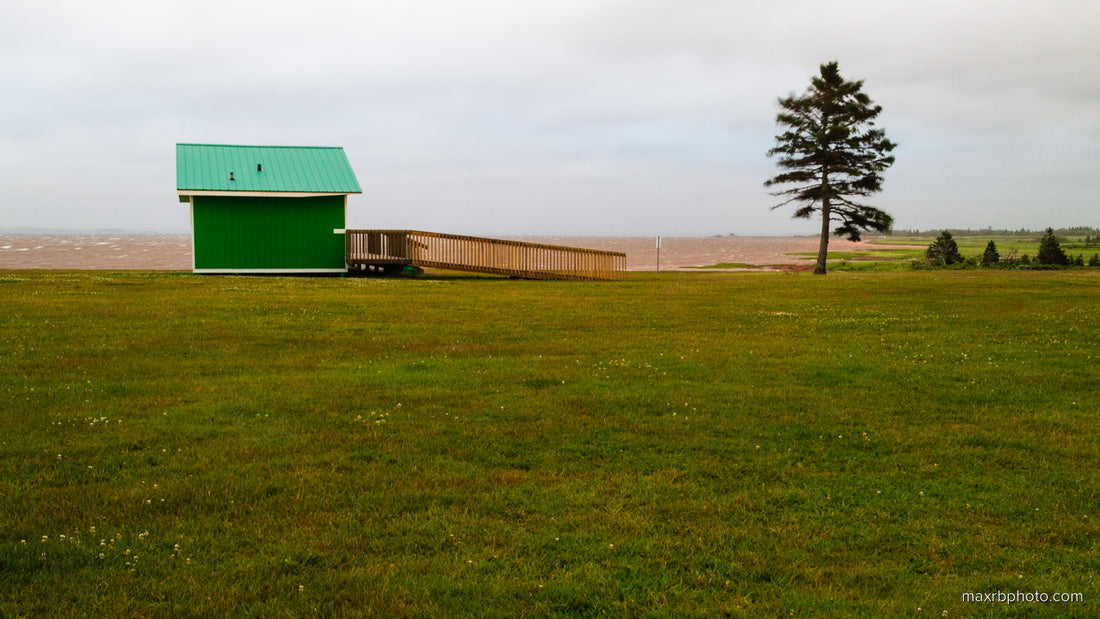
344,230,626,279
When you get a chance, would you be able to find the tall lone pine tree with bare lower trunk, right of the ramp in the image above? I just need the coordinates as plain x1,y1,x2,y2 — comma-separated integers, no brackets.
765,62,897,275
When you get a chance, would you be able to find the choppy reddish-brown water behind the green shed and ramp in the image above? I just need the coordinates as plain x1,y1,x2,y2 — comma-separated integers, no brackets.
0,234,906,270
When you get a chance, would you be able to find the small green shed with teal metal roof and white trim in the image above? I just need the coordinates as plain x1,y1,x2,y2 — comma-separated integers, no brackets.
176,144,363,274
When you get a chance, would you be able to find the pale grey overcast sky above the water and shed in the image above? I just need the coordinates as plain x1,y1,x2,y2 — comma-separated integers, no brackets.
0,0,1100,235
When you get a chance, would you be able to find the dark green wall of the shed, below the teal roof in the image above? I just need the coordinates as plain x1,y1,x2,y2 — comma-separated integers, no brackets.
191,196,347,272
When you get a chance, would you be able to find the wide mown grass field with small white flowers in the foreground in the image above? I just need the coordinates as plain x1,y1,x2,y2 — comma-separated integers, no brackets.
0,269,1100,617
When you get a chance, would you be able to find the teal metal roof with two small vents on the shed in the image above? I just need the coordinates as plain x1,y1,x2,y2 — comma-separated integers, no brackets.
176,144,363,194
